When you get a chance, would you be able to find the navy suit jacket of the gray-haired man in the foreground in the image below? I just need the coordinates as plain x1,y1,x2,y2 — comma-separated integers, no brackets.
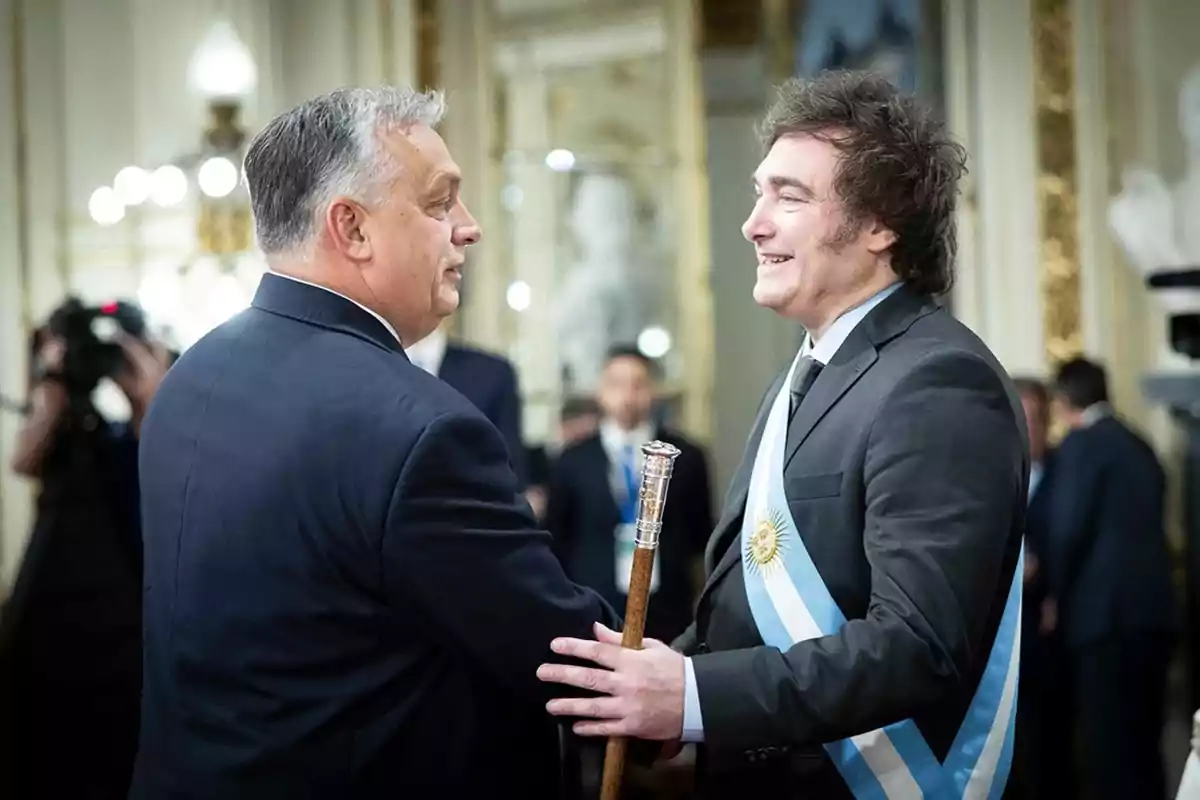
132,275,617,800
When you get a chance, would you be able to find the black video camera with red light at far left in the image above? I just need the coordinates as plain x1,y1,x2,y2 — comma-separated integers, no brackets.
47,297,146,397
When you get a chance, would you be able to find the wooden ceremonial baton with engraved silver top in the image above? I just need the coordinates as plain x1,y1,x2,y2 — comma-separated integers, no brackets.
600,441,679,800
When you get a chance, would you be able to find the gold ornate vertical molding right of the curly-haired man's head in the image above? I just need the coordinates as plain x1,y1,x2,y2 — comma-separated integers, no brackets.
1032,0,1084,369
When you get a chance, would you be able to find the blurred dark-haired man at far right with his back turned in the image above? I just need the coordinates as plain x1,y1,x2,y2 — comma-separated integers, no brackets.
1044,359,1180,800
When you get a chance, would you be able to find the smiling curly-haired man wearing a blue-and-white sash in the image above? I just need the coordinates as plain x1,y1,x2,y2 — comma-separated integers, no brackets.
540,72,1030,799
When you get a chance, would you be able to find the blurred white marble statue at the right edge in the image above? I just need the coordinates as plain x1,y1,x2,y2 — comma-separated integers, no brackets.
1109,64,1200,284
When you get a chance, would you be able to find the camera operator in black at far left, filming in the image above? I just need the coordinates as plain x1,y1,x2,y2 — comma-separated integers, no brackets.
0,300,170,800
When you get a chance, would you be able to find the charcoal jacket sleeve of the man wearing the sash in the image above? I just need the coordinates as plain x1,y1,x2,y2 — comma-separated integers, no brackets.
692,351,1026,754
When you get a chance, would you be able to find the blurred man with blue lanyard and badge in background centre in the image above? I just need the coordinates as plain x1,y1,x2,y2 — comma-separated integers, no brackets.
546,347,713,639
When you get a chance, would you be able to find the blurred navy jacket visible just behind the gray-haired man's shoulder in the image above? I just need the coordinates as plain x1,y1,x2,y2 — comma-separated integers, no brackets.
438,343,529,488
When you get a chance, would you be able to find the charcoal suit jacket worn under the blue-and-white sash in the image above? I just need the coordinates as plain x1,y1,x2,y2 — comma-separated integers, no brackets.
674,288,1030,798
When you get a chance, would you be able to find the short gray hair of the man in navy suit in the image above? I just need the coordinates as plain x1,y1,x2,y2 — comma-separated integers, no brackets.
245,86,445,255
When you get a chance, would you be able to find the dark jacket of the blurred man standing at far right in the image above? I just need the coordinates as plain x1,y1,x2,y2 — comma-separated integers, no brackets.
1044,416,1180,648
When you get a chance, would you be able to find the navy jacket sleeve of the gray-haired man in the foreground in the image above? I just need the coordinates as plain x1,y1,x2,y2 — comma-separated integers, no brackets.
382,413,619,699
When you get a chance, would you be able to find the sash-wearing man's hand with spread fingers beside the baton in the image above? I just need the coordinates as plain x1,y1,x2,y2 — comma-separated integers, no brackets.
538,622,684,740
